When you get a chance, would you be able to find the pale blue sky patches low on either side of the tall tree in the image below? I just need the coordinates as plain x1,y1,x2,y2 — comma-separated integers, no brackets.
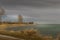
2,15,37,22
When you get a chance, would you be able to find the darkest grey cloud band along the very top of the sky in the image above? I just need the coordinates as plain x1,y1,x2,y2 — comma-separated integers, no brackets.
0,0,60,7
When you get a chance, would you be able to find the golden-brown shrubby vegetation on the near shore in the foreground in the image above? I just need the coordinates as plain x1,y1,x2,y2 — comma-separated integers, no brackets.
0,29,59,40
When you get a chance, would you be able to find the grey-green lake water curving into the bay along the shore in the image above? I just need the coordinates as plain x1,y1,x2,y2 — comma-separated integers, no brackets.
6,24,60,36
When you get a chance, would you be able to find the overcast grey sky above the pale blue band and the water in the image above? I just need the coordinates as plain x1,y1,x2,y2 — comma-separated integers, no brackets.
0,0,60,24
